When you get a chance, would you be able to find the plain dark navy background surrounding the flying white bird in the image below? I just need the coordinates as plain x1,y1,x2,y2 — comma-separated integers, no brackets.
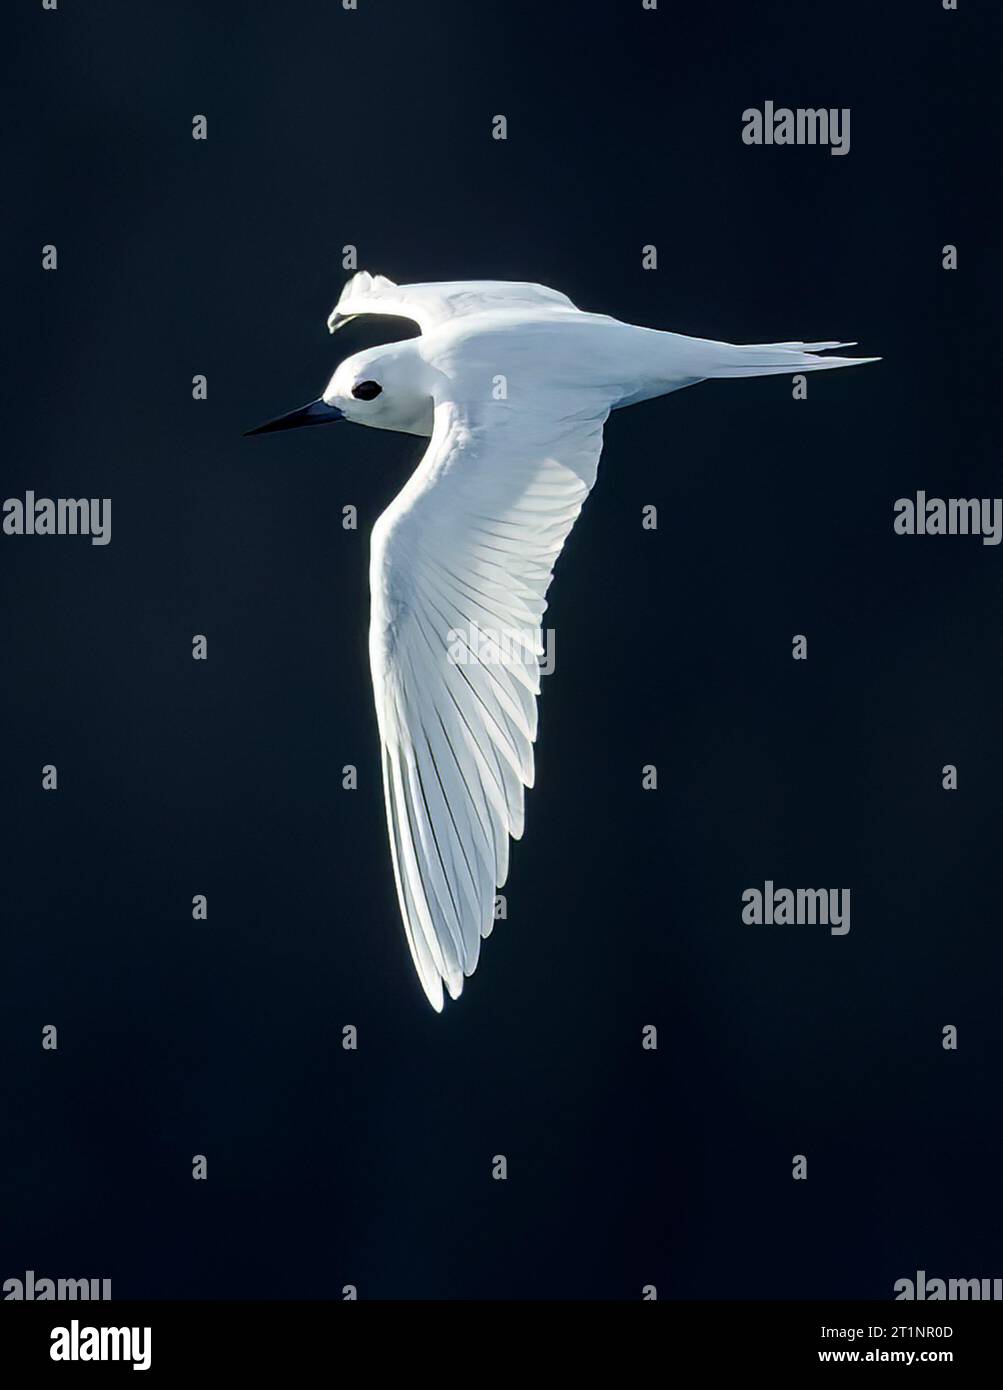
0,0,1003,1298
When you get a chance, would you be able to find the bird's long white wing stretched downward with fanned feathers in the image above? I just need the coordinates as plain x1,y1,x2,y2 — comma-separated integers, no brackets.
370,393,607,1009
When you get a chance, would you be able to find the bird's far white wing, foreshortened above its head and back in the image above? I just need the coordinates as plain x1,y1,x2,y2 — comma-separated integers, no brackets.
328,270,575,334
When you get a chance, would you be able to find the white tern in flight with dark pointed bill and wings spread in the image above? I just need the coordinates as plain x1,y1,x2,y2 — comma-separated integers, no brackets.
249,271,878,1011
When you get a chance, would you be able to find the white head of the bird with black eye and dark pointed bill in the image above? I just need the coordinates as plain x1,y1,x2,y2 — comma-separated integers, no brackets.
247,339,433,435
